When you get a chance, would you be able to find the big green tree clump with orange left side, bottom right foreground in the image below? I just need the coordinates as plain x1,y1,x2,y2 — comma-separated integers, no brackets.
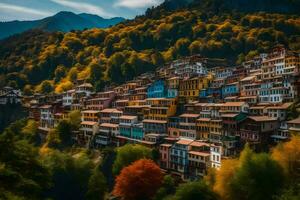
214,146,284,200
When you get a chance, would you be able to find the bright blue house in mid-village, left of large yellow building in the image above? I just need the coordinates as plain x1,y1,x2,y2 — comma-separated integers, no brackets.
147,80,167,98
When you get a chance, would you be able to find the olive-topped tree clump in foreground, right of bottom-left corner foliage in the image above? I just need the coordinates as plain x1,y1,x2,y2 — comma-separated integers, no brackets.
42,150,96,199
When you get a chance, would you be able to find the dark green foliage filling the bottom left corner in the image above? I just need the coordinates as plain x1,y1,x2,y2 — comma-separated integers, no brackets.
0,123,50,199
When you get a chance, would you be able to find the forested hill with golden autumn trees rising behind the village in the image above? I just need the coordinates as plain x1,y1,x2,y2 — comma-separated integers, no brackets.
0,0,300,94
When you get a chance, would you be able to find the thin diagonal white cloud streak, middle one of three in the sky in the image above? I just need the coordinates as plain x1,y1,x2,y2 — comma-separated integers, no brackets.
50,0,114,17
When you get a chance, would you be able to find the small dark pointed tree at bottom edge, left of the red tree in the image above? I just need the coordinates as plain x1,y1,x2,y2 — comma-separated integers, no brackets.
86,167,107,200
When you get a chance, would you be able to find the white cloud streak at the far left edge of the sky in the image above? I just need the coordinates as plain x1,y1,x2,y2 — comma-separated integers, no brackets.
0,3,53,19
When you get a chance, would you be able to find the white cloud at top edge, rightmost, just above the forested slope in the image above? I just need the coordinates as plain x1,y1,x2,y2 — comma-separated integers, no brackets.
114,0,163,9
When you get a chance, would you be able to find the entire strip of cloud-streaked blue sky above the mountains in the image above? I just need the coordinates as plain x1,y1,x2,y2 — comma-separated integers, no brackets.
0,0,163,21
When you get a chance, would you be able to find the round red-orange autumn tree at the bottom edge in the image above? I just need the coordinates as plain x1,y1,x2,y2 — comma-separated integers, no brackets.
113,159,163,200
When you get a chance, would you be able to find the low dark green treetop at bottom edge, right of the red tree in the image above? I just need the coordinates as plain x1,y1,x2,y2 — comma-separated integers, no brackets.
172,181,218,200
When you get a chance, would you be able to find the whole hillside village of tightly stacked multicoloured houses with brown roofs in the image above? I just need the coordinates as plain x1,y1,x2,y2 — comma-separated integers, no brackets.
0,45,300,179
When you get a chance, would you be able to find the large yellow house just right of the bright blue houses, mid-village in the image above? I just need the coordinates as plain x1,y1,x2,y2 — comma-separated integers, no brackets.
179,74,213,103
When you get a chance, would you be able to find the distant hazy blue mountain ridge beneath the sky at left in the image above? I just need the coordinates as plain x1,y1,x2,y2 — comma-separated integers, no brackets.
0,11,125,39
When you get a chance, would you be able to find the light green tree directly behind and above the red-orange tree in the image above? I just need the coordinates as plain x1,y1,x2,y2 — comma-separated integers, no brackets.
113,144,152,175
